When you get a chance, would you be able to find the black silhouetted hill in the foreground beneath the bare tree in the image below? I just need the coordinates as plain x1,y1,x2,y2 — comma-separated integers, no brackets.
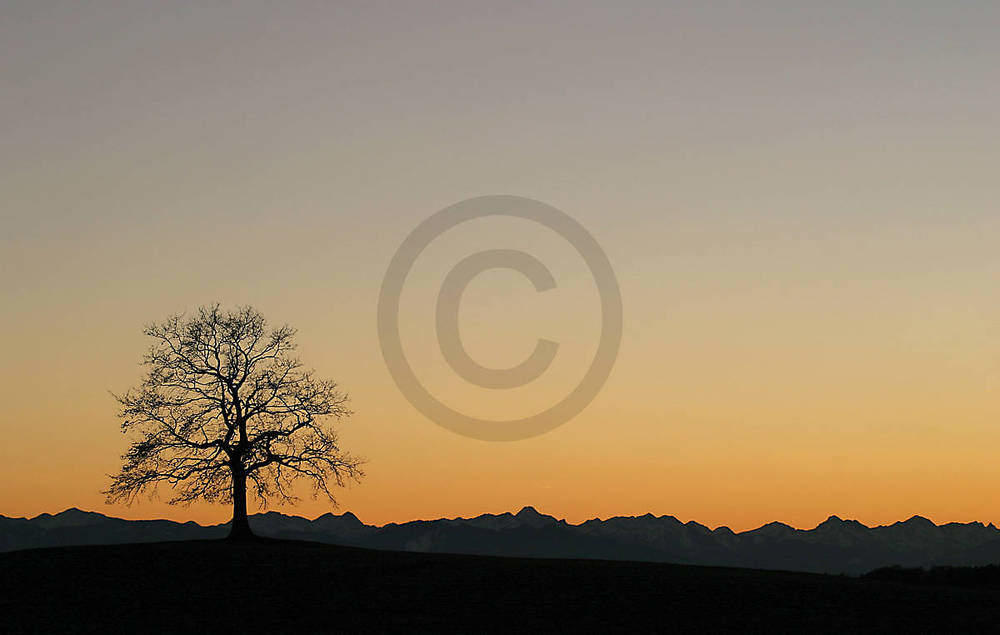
0,541,1000,633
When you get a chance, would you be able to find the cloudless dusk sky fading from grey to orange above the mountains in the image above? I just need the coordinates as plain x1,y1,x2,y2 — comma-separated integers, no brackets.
0,0,1000,530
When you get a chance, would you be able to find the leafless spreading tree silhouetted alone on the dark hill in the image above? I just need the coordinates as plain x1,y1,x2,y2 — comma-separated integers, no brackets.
104,304,363,538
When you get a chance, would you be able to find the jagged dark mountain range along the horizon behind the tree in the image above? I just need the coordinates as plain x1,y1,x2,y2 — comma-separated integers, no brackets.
0,507,1000,575
